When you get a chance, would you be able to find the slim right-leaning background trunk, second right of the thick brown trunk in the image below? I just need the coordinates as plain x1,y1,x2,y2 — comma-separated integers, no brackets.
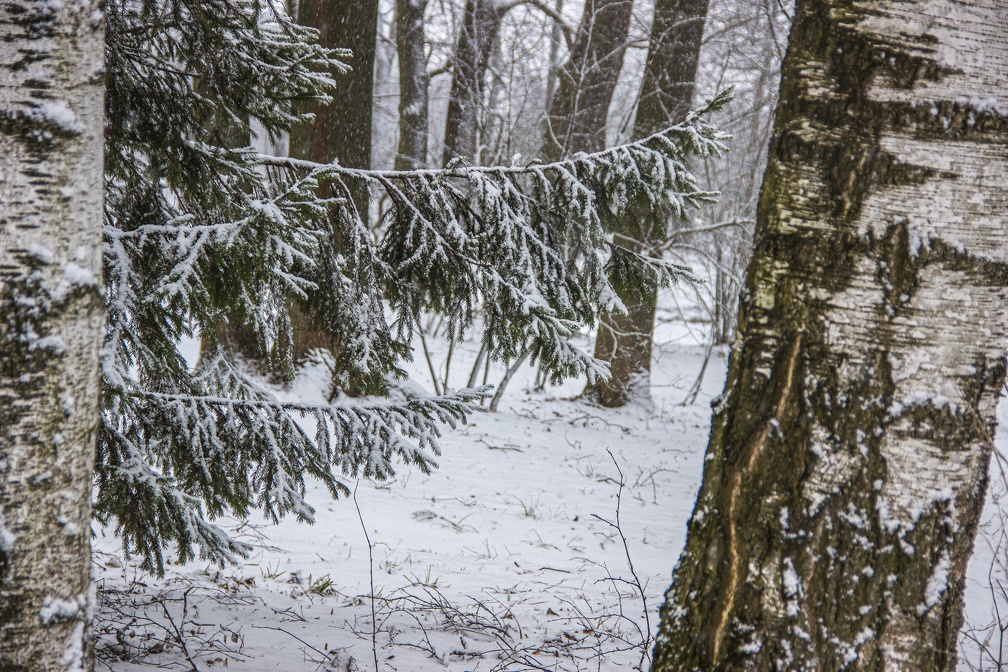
443,0,504,165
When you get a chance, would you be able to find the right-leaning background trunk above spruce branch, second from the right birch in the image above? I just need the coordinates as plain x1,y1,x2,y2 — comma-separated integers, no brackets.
542,0,633,161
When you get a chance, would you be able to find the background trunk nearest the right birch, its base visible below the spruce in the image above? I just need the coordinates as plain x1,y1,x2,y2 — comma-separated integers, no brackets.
589,0,708,406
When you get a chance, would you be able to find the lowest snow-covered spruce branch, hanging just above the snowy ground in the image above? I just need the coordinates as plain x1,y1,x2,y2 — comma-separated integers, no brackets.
95,353,489,571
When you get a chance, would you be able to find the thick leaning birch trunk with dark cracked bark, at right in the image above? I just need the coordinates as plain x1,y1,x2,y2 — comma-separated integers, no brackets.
652,0,1008,672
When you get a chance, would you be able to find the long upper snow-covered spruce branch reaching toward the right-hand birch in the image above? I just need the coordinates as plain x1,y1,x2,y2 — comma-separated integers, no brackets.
252,88,730,380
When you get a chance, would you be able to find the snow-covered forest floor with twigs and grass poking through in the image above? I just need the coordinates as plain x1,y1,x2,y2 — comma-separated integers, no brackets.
96,296,1008,672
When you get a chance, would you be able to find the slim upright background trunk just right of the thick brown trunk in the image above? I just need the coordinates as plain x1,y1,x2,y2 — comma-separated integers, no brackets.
395,0,427,170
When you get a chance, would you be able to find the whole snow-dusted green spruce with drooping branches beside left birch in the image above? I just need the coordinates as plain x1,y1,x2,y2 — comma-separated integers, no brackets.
95,0,725,571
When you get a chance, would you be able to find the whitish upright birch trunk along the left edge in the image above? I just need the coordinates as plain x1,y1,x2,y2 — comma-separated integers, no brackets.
0,0,105,671
